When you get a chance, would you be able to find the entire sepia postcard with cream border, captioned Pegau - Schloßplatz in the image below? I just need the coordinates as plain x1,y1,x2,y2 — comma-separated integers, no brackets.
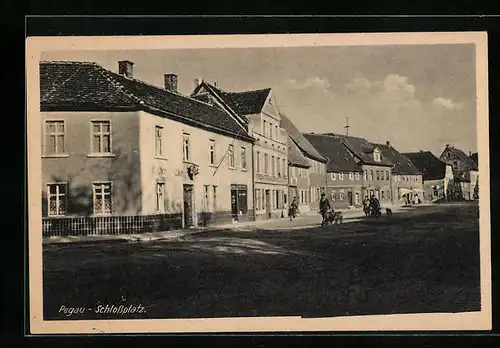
26,32,491,334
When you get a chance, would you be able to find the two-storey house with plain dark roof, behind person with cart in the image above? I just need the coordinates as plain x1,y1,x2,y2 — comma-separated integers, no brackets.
304,133,363,209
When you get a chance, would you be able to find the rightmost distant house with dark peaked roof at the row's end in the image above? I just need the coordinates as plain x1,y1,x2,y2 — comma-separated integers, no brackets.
439,144,479,200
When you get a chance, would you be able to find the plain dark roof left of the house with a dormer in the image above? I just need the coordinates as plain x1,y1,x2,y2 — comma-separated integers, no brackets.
304,134,363,173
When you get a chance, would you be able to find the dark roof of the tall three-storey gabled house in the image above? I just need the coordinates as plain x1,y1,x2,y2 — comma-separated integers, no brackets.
193,81,271,115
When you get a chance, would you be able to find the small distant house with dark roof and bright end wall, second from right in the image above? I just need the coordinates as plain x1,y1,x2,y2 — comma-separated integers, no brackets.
402,151,454,202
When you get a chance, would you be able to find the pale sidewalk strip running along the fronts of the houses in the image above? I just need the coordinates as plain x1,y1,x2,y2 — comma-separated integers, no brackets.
43,207,414,245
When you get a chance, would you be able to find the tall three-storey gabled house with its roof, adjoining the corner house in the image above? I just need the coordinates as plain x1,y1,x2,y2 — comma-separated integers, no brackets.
192,80,288,220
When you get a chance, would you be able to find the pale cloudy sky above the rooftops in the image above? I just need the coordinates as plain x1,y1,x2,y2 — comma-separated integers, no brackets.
41,44,477,156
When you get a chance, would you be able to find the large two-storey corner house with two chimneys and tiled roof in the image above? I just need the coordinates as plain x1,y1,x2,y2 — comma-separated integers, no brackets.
40,61,254,236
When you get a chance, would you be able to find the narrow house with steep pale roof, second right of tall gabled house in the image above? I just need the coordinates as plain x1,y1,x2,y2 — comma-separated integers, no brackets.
281,114,327,211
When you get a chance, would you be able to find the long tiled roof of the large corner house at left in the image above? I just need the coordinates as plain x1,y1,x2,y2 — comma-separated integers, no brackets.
40,62,253,141
